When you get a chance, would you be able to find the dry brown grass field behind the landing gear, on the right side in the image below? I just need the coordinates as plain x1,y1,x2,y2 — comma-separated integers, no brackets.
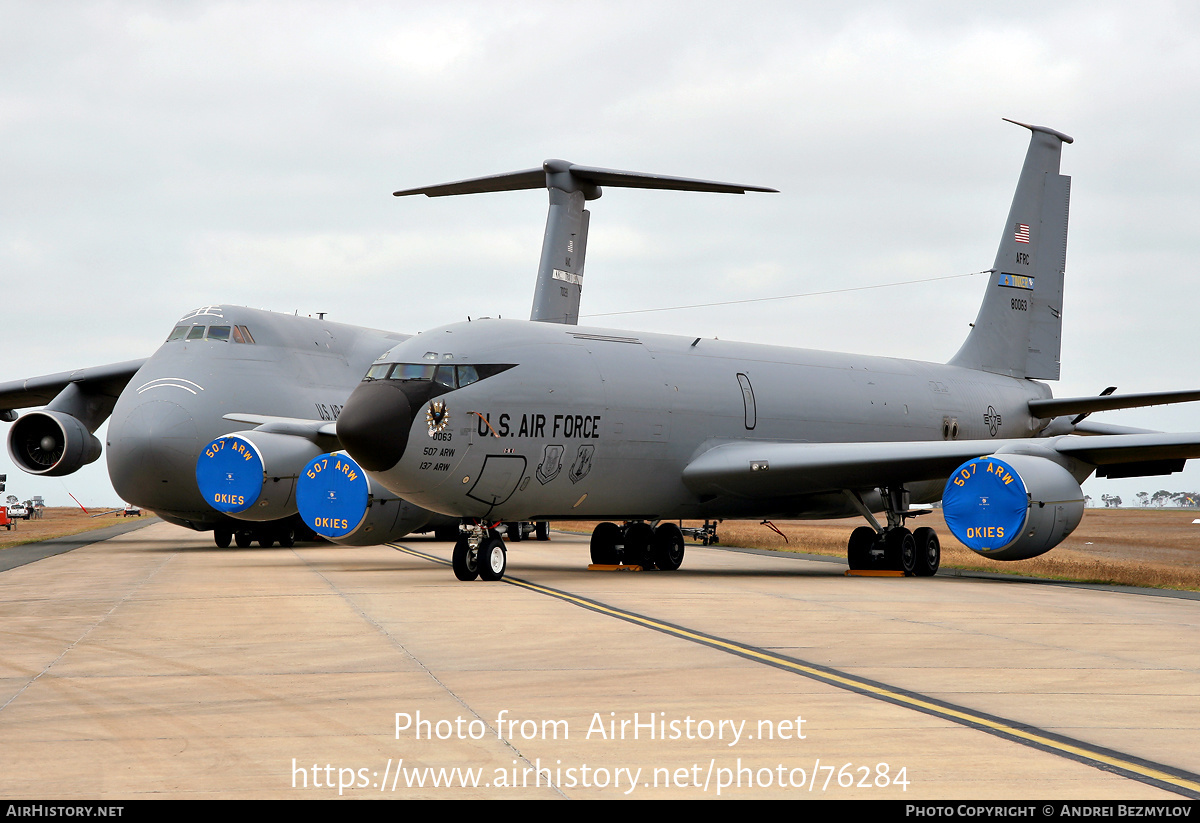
554,509,1200,590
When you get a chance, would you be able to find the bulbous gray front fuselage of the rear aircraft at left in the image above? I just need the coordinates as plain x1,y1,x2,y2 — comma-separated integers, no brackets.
104,306,407,529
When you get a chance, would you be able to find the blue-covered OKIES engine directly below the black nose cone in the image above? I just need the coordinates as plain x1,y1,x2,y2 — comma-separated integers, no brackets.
296,451,458,546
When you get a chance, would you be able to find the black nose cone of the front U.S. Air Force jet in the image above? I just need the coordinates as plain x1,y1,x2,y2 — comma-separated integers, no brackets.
337,380,413,471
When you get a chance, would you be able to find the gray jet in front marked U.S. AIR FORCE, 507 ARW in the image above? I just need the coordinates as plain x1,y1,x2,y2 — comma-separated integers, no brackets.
307,121,1200,579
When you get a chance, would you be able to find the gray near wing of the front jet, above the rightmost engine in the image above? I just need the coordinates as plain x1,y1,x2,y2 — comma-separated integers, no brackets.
683,432,1200,498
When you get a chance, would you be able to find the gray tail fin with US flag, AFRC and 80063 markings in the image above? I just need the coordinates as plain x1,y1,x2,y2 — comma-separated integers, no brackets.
950,120,1073,380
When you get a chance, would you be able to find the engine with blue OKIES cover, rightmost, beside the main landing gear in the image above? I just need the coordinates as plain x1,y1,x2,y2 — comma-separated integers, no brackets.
942,453,1084,560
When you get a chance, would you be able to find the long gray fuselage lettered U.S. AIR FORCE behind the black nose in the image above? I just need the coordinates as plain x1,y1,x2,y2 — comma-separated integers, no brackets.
338,320,1050,521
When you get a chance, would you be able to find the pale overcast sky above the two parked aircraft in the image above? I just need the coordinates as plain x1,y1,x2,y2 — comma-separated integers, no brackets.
0,0,1200,513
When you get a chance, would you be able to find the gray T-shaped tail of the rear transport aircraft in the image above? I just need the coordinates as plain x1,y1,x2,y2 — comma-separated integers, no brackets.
394,160,778,325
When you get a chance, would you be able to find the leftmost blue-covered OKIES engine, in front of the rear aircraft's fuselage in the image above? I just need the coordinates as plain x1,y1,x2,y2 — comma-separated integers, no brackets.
196,431,322,522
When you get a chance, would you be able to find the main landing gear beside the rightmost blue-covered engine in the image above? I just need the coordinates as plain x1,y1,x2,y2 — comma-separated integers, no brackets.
846,487,942,577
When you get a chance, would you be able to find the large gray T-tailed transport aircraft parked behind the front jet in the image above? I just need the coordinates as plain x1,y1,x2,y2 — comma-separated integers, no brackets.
0,161,772,547
